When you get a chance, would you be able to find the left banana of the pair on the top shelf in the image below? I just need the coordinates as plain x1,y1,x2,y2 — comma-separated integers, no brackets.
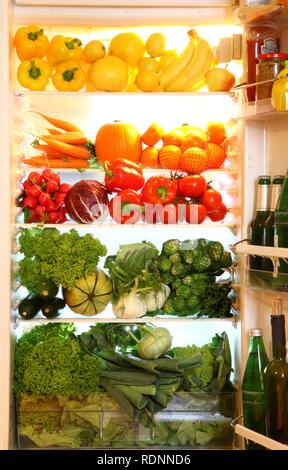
155,29,197,91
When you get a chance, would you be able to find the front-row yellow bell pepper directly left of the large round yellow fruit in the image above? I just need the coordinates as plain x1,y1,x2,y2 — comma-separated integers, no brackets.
52,61,86,91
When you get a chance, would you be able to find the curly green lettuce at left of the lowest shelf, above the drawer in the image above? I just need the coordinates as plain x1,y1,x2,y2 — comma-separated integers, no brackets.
14,323,100,395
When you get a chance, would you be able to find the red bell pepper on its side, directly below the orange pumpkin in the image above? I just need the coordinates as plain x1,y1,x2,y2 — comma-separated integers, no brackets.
104,158,145,192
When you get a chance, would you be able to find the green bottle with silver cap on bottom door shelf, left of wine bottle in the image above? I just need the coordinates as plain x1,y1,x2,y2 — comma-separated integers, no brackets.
242,329,268,450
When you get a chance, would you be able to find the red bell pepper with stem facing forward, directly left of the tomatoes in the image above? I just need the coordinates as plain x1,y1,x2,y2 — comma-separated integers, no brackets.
142,176,177,204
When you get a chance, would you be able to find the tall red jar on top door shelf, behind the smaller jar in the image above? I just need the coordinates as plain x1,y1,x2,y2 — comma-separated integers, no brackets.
246,23,280,101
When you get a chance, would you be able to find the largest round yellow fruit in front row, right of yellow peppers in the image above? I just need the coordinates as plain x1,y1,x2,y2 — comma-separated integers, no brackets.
88,56,129,91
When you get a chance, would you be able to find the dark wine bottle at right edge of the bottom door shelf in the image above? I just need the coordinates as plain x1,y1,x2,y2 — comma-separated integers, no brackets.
265,299,288,444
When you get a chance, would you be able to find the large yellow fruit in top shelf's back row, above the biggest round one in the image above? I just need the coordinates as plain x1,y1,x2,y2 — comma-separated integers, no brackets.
108,33,145,67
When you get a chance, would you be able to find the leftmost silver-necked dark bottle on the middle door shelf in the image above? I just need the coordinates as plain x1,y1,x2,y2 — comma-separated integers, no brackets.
250,175,271,269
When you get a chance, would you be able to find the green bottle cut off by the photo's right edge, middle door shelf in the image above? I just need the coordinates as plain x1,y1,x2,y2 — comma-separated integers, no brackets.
274,175,288,273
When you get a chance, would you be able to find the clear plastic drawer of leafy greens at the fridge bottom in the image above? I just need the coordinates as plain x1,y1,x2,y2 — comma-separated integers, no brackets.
16,390,236,449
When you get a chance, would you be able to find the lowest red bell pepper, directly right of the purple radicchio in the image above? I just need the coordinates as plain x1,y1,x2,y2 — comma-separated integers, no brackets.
108,189,144,224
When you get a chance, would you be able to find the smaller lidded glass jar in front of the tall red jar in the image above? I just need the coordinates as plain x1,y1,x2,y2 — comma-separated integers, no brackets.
256,53,288,100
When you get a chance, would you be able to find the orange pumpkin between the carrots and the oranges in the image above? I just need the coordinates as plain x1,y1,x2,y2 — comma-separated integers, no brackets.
95,121,142,163
